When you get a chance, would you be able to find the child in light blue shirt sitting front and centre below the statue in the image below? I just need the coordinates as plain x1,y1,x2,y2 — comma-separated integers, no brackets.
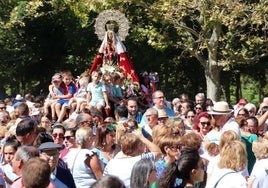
87,71,110,111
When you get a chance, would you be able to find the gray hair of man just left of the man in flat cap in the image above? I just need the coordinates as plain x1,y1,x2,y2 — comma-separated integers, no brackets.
16,146,38,163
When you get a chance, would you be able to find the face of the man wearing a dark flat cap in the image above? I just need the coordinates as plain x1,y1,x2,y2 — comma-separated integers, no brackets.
39,149,60,171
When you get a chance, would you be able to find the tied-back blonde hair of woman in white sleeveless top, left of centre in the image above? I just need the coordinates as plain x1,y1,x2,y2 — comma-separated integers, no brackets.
75,127,93,148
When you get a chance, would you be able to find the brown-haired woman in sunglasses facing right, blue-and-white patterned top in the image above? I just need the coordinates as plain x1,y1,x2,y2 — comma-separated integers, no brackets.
93,125,116,169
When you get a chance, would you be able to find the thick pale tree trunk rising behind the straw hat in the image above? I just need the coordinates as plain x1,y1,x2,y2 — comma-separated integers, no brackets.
205,60,222,101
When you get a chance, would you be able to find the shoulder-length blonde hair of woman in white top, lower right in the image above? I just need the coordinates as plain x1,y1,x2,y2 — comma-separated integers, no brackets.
218,140,247,172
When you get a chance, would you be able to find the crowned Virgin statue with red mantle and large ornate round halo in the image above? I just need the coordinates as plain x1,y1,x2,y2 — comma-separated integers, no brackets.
89,10,139,84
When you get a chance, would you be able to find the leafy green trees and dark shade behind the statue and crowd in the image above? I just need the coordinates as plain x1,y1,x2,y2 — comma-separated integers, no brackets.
0,0,268,103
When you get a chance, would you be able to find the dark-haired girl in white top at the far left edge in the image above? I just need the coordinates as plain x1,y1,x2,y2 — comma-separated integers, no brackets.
2,136,20,187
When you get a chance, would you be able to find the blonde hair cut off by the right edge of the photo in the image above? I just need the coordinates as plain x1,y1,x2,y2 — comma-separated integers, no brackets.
252,139,268,160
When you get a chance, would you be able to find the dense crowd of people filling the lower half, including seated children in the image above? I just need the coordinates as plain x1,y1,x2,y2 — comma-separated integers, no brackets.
0,71,268,188
